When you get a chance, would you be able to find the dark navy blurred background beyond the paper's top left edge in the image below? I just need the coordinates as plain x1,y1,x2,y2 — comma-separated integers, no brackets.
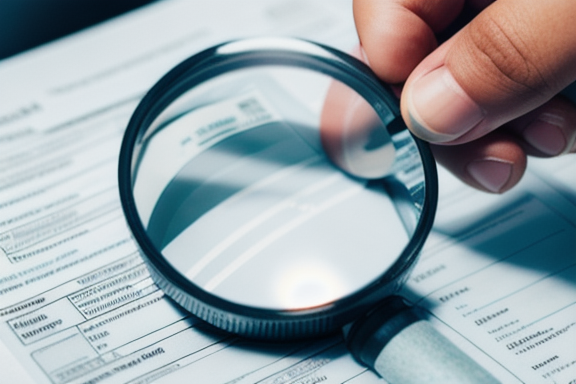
0,0,155,60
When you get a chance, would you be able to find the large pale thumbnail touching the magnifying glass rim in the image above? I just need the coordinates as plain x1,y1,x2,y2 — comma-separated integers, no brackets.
407,66,485,143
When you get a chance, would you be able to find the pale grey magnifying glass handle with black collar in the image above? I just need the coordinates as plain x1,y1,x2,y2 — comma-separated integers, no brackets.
346,296,500,384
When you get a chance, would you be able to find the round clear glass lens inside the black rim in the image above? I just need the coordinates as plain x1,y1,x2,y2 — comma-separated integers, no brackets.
134,68,423,310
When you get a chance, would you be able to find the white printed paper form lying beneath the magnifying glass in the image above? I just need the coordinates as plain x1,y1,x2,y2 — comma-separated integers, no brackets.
0,0,576,384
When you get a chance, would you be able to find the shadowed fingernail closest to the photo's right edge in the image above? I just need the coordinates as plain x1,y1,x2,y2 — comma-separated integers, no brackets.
522,113,570,156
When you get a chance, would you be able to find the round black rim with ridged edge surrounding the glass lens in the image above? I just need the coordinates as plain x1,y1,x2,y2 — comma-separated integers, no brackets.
118,38,438,340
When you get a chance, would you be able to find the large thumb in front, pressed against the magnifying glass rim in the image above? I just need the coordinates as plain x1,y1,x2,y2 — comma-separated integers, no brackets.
401,0,576,144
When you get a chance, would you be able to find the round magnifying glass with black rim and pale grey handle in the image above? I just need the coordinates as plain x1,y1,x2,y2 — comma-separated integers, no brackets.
119,38,494,383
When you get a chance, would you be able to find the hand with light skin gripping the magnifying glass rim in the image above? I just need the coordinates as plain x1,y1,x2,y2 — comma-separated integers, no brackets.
340,0,576,193
